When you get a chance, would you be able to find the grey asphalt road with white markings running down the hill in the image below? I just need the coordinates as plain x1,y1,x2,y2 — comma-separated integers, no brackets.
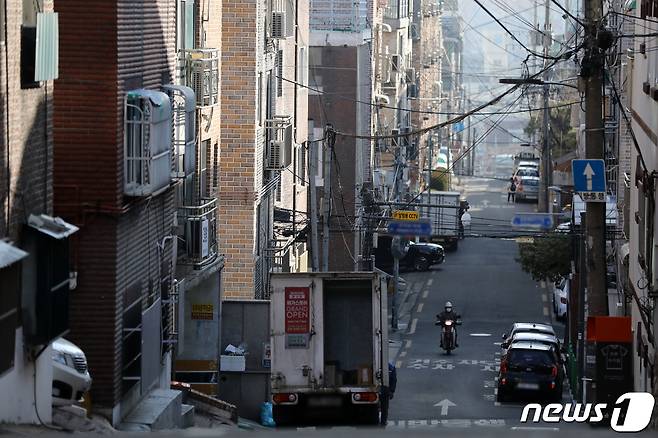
388,178,568,428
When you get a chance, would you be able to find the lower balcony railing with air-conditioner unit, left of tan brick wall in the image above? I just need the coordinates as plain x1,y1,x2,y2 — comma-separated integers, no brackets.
178,198,217,269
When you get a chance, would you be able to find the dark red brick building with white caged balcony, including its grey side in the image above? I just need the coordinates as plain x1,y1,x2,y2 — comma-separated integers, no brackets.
53,0,177,424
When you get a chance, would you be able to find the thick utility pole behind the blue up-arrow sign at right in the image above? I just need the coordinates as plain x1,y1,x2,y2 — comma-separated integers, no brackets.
581,0,608,316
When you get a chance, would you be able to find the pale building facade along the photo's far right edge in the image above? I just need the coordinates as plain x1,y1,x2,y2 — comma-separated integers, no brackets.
625,2,658,400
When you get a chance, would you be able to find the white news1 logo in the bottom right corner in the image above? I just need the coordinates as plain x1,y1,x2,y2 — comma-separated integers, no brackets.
521,392,655,432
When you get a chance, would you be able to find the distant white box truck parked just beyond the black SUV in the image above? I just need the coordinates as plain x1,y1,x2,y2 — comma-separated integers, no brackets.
418,190,460,250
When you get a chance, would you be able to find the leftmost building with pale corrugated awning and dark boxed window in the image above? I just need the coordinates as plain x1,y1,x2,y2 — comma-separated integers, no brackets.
0,0,76,423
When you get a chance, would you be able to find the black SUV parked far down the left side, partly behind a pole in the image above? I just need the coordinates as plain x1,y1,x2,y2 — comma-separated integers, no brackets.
375,236,445,273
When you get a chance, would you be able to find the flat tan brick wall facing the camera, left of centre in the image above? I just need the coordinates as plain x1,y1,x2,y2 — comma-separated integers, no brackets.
218,0,264,298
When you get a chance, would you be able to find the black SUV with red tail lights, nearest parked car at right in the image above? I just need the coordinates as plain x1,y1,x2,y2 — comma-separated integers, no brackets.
498,342,564,402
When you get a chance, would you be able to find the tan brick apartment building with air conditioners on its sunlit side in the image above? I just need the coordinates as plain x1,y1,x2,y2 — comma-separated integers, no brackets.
218,0,308,298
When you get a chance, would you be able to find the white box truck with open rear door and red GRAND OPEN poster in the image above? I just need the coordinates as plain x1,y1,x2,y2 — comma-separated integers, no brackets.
270,272,388,426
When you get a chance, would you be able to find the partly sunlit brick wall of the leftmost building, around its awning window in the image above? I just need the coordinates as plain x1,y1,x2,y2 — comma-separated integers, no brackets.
0,0,53,241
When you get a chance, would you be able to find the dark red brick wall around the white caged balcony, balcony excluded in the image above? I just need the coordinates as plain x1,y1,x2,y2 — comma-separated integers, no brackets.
55,0,176,414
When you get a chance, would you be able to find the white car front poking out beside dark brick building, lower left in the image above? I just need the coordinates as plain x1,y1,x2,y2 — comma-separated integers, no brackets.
52,338,91,406
